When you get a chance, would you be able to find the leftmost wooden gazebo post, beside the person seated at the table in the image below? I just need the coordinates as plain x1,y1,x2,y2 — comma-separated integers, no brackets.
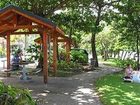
6,33,10,69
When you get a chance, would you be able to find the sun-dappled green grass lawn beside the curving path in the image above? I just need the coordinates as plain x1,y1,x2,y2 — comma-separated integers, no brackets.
96,73,140,105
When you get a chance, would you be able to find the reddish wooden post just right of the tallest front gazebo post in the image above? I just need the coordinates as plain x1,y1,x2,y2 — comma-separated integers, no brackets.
53,36,57,75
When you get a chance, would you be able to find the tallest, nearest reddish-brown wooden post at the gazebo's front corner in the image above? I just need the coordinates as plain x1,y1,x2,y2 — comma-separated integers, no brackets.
43,31,48,84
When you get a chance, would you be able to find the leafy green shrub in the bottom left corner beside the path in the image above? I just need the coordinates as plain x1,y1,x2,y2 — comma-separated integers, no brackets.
0,82,36,105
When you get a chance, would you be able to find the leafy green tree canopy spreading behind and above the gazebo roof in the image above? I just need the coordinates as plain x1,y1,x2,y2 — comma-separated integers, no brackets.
0,0,140,67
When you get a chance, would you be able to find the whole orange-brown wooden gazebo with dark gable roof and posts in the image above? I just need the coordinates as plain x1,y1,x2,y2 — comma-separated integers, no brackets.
0,5,71,83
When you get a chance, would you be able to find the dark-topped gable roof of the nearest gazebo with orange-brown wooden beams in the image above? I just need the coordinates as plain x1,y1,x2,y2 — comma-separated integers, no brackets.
0,5,69,40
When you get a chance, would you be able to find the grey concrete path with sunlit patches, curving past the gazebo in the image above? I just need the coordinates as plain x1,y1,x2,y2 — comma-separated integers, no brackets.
0,66,120,105
